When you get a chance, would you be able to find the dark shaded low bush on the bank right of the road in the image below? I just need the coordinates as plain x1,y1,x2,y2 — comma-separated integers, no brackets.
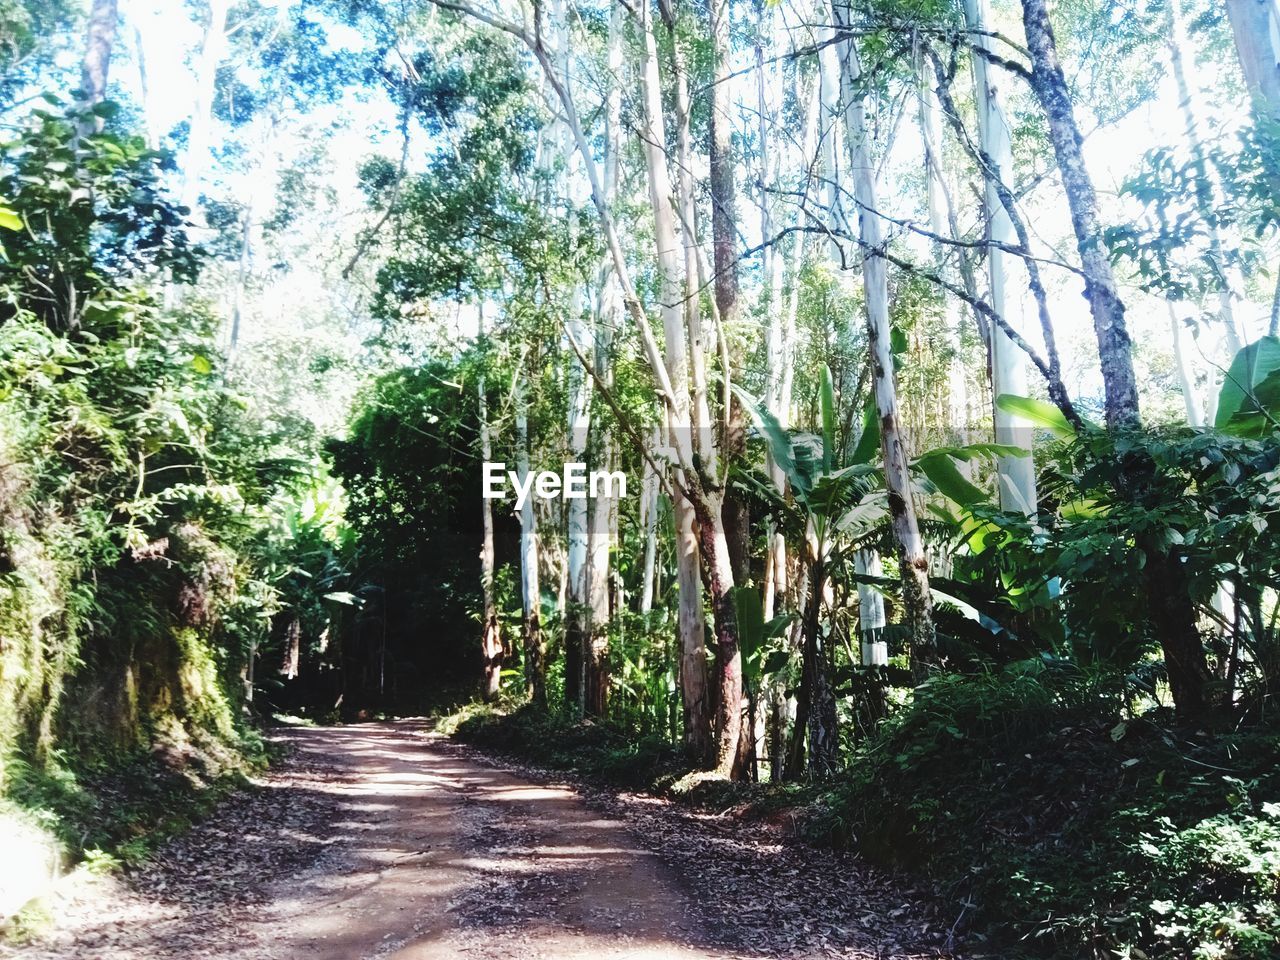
812,663,1280,960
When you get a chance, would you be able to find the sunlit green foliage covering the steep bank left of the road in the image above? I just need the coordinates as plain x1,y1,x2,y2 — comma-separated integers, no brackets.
0,110,335,870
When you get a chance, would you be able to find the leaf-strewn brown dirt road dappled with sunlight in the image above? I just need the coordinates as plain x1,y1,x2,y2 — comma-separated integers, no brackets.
0,721,940,960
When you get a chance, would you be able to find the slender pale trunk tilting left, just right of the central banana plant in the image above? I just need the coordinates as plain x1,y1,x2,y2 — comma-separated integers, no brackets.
834,6,937,686
